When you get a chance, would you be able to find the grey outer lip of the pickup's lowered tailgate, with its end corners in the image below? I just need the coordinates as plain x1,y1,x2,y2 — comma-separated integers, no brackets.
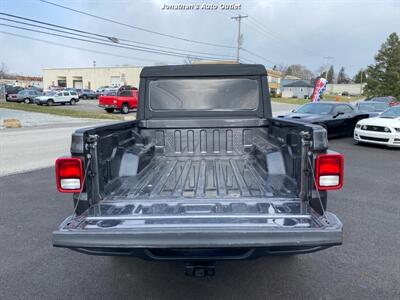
53,212,343,255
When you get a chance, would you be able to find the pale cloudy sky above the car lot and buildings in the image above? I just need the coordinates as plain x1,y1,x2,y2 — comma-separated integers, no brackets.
0,0,400,76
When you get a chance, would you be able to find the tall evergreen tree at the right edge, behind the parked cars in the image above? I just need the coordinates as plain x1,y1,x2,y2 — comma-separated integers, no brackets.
365,32,400,98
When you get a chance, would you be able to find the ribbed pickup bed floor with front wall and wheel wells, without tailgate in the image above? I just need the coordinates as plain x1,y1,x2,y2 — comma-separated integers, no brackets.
101,128,297,201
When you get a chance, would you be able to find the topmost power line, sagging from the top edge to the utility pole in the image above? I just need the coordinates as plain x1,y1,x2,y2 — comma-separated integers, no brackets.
39,0,234,49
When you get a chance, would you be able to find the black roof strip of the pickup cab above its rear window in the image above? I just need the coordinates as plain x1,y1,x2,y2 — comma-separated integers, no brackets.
140,64,267,78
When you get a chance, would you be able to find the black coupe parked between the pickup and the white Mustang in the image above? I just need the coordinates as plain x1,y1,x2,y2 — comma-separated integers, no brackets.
278,101,369,137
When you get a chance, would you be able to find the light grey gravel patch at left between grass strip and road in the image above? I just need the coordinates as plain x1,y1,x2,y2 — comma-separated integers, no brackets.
0,108,93,129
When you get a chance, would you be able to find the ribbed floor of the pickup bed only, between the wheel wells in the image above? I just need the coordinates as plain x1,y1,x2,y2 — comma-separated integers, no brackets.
106,155,296,201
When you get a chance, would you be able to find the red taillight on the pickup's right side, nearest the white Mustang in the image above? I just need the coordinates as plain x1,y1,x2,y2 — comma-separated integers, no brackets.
315,154,344,191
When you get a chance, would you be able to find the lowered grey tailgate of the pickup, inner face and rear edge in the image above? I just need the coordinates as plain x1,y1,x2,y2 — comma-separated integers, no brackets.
53,199,342,248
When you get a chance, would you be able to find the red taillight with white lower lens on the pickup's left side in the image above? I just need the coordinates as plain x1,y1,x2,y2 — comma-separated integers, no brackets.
56,157,83,193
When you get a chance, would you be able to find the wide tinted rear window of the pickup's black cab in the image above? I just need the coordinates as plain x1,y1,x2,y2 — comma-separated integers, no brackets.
149,78,260,111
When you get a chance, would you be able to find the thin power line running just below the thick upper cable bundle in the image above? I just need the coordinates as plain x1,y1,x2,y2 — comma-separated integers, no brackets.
0,23,236,61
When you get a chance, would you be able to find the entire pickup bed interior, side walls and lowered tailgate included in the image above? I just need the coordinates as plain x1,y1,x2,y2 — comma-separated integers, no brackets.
53,120,342,253
